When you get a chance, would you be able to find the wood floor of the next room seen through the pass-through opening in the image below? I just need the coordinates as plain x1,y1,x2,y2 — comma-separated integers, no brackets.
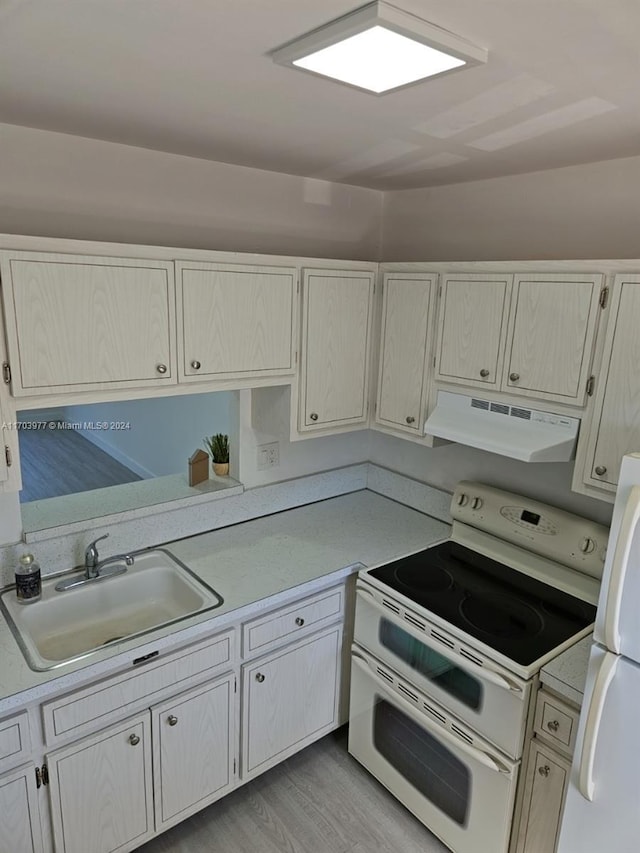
18,429,142,503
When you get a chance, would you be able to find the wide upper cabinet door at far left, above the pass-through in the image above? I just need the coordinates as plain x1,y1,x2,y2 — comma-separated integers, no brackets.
1,253,176,397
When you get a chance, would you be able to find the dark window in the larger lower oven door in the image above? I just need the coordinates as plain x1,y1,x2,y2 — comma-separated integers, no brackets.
373,696,471,826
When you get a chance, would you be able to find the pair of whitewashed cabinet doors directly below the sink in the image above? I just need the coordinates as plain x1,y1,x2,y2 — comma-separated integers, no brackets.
47,673,235,853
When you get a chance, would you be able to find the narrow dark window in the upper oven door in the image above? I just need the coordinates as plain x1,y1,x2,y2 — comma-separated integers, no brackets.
378,619,483,711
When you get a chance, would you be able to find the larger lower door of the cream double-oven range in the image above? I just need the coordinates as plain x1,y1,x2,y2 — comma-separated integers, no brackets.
349,647,518,853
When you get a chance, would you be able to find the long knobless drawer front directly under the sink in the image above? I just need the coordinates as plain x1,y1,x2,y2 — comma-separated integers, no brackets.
42,631,235,745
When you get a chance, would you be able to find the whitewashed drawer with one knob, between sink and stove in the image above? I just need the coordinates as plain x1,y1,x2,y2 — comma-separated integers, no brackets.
242,586,344,658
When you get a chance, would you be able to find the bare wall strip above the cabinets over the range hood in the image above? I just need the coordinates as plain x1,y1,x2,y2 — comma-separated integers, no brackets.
382,152,640,261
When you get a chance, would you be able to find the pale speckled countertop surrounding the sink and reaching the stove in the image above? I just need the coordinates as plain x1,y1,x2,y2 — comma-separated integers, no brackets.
0,490,450,715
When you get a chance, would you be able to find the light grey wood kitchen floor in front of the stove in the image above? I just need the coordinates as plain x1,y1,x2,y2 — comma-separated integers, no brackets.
139,727,448,853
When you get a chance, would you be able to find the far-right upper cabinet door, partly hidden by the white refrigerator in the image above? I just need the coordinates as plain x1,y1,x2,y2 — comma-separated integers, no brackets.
584,274,640,486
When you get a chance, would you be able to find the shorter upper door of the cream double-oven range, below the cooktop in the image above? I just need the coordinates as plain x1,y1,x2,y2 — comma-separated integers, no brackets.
354,582,531,758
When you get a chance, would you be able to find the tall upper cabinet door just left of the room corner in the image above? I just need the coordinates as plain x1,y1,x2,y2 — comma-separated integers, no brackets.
299,269,375,431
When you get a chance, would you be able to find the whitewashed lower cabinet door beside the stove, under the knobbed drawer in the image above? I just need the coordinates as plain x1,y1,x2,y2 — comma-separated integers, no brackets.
242,625,342,779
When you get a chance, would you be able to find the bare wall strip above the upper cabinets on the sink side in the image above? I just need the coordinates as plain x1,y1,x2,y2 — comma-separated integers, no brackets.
0,124,382,260
